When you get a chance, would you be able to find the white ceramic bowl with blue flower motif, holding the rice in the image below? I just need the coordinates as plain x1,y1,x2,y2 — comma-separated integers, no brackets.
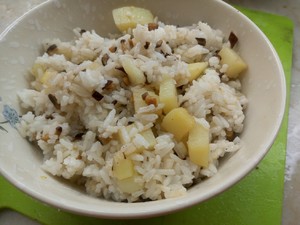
0,0,286,218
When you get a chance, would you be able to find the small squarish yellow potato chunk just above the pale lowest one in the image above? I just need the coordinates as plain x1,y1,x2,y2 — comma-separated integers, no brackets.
113,159,134,180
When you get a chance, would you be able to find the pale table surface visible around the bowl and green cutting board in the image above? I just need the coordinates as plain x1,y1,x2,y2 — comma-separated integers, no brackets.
0,0,300,225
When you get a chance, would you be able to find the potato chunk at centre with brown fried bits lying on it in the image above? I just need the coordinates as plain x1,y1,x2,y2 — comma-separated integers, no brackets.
131,86,161,114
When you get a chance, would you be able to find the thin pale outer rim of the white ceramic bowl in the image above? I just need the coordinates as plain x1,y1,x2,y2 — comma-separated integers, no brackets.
0,0,287,219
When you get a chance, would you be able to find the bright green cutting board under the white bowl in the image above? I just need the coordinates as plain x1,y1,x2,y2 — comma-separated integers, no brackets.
0,7,293,225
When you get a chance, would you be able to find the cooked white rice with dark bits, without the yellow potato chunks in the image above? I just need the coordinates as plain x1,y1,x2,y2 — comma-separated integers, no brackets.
18,19,247,202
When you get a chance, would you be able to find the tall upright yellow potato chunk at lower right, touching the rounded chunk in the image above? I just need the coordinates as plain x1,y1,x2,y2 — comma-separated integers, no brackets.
187,123,209,167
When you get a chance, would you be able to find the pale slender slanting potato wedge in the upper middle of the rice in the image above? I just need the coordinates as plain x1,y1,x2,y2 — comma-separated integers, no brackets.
121,56,146,85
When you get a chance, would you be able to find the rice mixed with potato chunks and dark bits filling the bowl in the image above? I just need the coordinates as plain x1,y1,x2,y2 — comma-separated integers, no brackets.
18,7,247,202
